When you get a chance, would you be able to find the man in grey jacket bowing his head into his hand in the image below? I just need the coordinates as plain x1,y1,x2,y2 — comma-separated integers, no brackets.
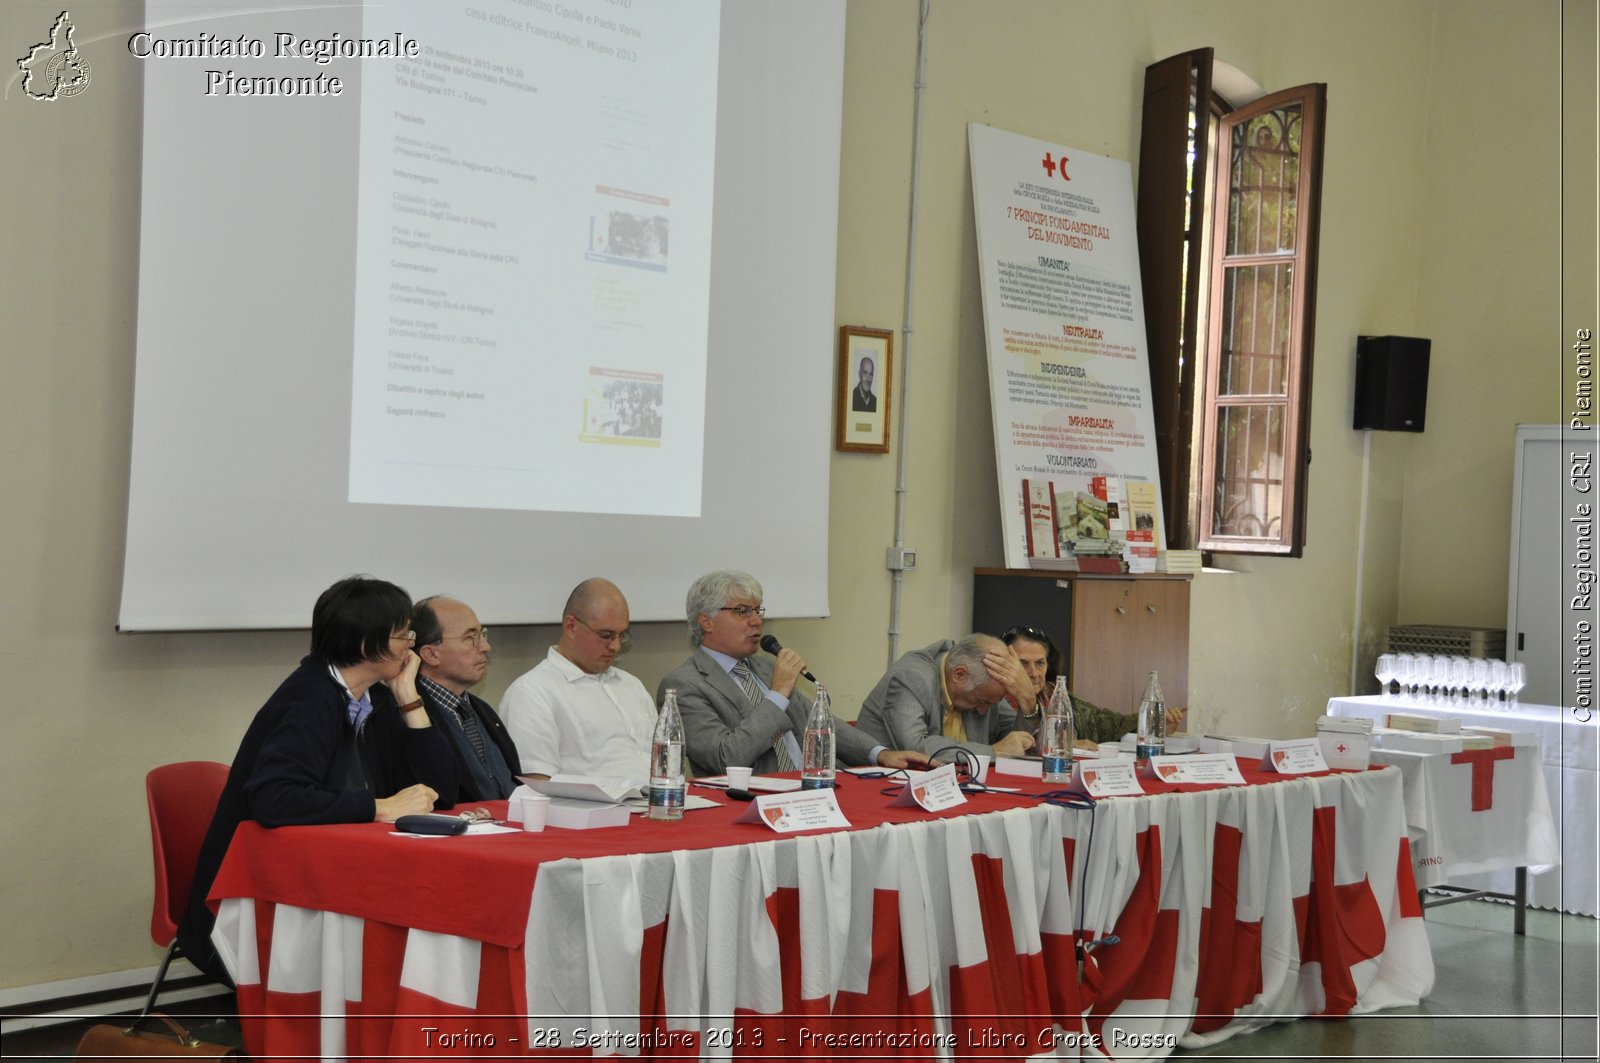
856,634,1034,757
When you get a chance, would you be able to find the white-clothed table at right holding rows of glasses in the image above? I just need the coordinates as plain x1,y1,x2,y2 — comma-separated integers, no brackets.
1328,695,1600,916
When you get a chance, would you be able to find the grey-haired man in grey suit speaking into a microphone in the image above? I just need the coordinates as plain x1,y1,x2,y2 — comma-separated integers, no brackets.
656,572,928,775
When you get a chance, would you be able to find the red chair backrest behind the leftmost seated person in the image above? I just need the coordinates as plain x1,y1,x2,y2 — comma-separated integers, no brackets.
144,760,227,948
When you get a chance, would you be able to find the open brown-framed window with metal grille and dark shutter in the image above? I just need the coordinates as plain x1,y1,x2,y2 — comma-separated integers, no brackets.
1139,48,1325,557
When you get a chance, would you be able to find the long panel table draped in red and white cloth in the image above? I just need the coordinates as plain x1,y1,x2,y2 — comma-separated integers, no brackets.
211,765,1434,1060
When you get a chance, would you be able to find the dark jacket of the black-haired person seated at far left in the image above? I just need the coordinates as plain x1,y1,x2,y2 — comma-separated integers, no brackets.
178,656,456,985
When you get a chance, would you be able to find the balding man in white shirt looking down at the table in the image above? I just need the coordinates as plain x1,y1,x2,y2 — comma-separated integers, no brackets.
501,576,656,781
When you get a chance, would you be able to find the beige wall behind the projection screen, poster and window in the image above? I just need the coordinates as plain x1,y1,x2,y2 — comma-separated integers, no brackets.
0,0,1574,988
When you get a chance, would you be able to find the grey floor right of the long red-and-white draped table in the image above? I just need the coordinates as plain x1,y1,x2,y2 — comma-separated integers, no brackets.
1171,901,1600,1063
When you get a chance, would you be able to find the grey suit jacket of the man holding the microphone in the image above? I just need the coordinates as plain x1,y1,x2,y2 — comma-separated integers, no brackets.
656,648,878,775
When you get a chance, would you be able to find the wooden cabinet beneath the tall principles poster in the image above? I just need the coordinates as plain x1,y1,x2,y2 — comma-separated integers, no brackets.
973,568,1189,712
